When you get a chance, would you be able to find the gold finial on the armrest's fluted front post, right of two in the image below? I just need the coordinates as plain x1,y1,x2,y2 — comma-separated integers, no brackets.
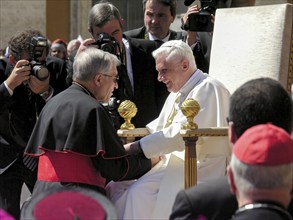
180,98,200,130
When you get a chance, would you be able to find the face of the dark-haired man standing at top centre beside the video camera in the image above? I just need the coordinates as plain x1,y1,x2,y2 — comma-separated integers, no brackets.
144,0,174,39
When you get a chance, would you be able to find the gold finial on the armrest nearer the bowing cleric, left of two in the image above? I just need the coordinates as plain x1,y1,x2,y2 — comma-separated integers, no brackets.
118,100,137,130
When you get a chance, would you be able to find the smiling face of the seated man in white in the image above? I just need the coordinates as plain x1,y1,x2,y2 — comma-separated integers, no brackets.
156,55,190,92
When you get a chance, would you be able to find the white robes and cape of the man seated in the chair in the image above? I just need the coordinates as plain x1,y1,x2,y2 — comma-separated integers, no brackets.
106,70,230,219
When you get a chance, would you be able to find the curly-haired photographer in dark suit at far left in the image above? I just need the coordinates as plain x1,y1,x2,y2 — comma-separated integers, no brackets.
0,30,64,219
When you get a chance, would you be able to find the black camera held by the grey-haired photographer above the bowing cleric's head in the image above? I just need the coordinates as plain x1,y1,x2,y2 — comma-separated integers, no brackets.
93,33,118,56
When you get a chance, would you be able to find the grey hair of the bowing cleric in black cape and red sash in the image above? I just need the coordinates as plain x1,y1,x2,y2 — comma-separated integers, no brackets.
72,47,120,81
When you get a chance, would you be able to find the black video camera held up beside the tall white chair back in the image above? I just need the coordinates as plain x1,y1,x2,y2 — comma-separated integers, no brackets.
187,0,217,32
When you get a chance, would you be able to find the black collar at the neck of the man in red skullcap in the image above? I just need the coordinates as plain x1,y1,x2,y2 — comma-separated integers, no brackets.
235,202,293,220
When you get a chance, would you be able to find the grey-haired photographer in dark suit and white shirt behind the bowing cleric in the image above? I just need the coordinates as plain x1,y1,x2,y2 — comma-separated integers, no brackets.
88,3,168,127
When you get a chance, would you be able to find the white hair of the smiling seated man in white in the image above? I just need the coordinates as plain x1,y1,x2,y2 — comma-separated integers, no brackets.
152,40,197,69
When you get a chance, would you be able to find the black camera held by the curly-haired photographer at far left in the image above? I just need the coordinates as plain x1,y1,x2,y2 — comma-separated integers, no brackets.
29,36,50,81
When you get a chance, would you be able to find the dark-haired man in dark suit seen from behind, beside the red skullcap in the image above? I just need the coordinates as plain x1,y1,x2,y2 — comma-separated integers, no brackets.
170,78,293,220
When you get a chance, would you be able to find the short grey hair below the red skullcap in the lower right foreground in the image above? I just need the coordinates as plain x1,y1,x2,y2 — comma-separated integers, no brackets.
230,155,293,192
